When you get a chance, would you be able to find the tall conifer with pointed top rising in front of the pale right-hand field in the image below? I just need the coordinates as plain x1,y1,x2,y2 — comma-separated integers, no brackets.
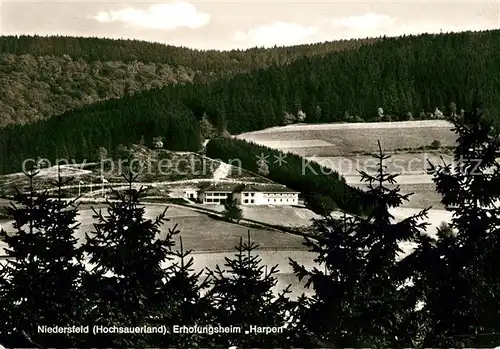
356,142,429,347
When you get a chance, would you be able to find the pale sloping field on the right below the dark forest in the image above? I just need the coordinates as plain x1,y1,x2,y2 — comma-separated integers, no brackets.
237,120,456,193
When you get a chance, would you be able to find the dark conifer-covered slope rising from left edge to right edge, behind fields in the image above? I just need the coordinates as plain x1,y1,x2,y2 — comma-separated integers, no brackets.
0,31,500,172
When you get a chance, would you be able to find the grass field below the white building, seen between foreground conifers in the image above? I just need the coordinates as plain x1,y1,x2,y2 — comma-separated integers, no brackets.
0,204,313,297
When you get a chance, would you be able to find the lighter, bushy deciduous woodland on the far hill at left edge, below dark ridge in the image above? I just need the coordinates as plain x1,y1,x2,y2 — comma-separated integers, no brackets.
0,54,199,127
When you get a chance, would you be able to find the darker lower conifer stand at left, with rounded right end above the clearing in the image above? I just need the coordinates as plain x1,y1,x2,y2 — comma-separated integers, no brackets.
0,97,201,172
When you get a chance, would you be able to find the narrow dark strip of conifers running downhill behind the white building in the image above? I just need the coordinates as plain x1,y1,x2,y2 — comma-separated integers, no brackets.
206,138,369,214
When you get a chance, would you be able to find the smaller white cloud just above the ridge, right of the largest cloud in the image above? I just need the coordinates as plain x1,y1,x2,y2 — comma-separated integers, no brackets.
233,22,318,47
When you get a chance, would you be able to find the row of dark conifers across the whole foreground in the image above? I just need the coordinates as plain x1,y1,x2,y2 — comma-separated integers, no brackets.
0,100,500,348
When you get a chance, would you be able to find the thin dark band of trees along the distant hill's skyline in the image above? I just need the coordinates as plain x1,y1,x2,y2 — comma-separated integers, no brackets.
0,35,382,74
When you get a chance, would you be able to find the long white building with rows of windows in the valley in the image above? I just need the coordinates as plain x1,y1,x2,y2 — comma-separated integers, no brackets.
198,184,299,205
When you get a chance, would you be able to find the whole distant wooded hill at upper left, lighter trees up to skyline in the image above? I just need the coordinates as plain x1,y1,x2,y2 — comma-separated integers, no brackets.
0,36,379,127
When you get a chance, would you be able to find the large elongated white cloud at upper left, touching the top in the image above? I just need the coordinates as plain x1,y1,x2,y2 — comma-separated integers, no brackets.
93,2,210,30
